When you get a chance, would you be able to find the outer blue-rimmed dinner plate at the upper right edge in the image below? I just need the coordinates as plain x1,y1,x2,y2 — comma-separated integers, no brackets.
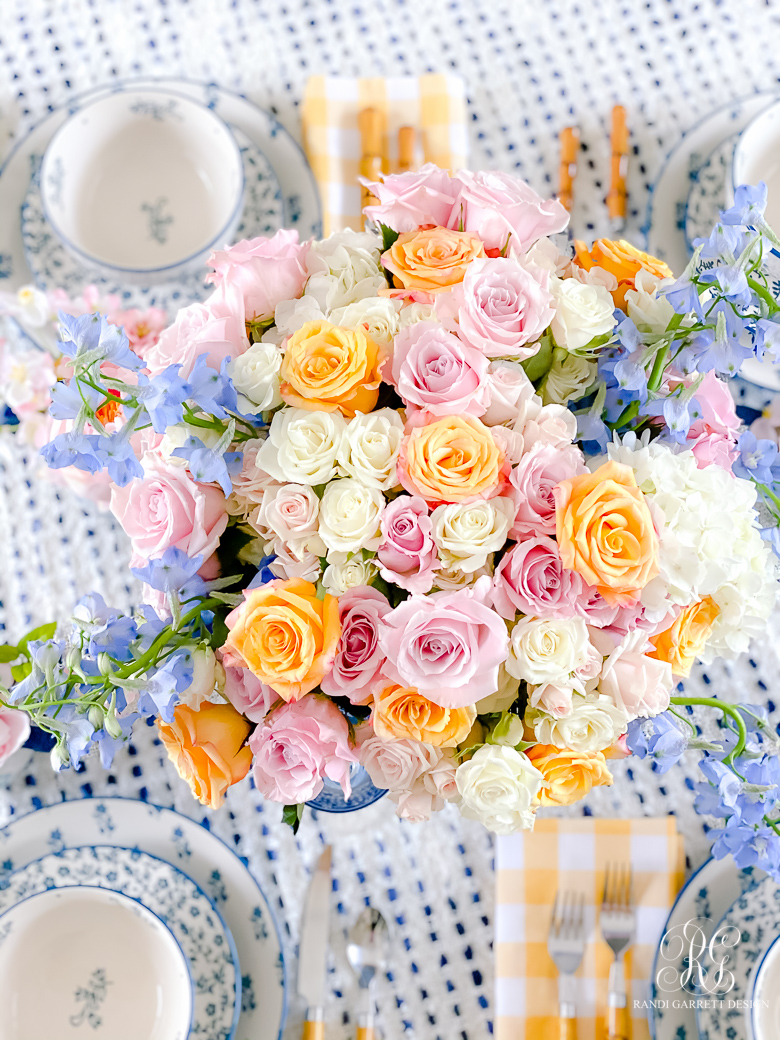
644,93,777,275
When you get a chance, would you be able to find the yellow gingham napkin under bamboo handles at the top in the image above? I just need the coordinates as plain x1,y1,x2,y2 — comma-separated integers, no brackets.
302,73,468,235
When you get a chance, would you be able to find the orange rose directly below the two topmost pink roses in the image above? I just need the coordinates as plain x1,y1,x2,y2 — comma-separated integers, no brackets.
382,228,485,292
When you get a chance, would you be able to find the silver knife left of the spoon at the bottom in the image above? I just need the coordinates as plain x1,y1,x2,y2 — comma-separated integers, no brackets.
297,846,331,1040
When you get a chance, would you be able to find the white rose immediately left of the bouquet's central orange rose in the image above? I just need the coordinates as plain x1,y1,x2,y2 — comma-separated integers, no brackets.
339,408,404,491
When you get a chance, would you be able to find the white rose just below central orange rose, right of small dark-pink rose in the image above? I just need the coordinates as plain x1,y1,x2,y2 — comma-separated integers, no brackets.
431,498,517,574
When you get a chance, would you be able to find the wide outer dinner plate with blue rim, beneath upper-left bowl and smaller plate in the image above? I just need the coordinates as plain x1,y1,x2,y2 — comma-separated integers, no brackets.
0,76,322,347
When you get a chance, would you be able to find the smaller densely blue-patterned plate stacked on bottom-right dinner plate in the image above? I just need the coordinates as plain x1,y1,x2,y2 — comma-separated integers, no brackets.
696,878,780,1040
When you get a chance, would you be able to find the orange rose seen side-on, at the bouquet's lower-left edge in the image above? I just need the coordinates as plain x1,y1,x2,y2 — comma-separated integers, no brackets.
157,701,254,809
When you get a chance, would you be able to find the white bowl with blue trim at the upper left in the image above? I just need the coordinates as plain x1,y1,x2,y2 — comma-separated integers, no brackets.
41,87,244,284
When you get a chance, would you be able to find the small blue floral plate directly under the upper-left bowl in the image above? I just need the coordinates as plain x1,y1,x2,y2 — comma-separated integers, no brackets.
22,128,284,318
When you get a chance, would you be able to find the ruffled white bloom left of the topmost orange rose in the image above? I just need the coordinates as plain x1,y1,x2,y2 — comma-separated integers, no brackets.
304,231,387,314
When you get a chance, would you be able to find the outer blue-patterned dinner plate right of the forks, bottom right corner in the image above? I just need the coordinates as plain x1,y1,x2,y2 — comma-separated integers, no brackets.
648,857,764,1040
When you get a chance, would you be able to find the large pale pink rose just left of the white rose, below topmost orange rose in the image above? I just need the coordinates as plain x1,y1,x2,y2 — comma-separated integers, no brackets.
436,257,555,360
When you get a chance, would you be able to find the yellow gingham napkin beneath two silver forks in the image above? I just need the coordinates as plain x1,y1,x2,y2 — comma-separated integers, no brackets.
495,816,684,1040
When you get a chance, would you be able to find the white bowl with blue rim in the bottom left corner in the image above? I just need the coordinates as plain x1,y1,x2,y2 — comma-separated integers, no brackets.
0,886,193,1040
